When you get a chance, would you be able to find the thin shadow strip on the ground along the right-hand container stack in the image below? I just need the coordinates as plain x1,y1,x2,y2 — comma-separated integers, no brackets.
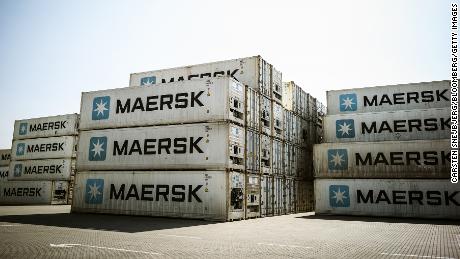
297,213,460,225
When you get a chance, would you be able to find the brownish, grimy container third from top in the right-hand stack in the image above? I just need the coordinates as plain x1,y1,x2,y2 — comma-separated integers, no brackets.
313,139,450,178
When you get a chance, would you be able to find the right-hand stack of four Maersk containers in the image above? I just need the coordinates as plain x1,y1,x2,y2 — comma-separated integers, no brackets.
314,81,460,219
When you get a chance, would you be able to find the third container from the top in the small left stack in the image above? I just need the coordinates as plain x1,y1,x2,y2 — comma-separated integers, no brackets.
8,158,75,181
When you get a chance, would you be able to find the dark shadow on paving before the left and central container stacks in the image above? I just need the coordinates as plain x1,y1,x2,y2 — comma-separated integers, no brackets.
0,213,217,233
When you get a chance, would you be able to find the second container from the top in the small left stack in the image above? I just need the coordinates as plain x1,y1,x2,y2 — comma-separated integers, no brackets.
11,136,78,160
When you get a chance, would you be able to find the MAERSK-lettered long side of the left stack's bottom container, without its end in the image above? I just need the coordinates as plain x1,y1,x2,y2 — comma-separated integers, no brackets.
0,181,53,204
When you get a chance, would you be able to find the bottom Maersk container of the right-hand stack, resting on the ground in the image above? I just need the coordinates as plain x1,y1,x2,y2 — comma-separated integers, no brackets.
315,179,460,219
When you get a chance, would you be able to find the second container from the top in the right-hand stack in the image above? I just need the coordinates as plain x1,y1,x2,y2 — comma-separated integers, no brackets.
324,108,451,143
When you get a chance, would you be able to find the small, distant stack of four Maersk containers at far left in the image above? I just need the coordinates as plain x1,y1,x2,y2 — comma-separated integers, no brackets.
0,114,79,204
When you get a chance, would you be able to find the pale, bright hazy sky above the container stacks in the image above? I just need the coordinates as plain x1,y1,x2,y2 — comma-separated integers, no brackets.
0,0,451,149
